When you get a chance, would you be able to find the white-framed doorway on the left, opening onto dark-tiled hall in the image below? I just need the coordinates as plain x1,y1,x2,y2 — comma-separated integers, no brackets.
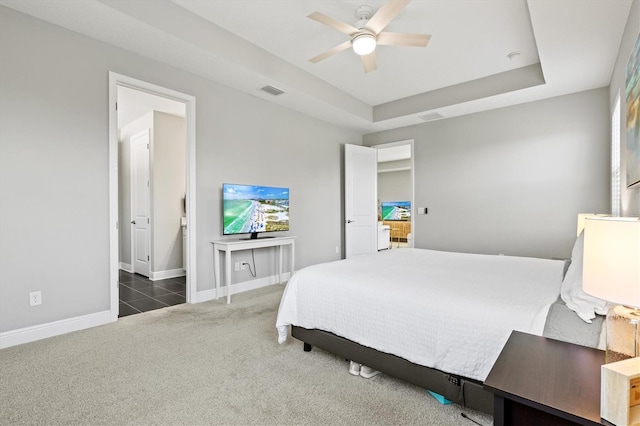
109,73,196,321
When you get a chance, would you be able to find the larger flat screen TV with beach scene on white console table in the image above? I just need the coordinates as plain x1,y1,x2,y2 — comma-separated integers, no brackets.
222,183,289,239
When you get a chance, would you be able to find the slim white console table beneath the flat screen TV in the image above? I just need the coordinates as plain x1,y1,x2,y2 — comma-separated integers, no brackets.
211,237,296,303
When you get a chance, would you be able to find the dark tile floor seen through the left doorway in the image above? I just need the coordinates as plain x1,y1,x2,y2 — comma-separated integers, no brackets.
118,270,187,317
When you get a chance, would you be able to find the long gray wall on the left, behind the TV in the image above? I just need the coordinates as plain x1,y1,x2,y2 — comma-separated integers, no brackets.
0,7,361,332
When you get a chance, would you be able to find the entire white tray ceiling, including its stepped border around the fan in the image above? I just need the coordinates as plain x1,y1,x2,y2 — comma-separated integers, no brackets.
0,0,632,133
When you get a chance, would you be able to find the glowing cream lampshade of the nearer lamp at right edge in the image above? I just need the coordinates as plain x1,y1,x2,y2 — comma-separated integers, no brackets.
582,217,640,308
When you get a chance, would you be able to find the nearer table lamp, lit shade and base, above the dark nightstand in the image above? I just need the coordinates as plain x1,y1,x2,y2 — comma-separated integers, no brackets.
582,217,640,363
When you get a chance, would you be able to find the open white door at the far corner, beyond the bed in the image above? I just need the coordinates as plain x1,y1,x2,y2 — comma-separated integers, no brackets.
344,144,378,258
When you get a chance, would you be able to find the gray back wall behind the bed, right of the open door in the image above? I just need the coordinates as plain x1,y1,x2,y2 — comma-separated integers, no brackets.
364,88,610,258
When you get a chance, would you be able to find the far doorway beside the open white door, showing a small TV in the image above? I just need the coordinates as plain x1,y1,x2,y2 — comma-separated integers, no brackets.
373,140,416,250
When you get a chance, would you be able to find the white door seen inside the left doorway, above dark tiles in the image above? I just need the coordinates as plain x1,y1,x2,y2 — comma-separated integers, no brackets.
131,130,151,277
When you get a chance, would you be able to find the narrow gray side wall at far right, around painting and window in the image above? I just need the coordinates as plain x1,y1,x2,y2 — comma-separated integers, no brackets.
609,0,640,217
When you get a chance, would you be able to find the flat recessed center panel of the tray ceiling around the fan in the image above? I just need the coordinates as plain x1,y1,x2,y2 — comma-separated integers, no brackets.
174,0,538,105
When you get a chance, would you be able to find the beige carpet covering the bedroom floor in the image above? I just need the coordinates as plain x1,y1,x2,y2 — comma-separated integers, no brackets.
0,285,492,426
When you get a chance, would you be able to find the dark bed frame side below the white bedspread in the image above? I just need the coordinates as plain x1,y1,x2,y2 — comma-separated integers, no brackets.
291,325,493,414
